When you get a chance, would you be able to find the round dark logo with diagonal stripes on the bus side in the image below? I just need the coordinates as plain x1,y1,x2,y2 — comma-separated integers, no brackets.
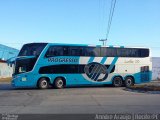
84,62,108,82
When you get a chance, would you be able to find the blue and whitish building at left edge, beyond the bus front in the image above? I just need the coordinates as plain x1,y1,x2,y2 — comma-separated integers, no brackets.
0,44,19,78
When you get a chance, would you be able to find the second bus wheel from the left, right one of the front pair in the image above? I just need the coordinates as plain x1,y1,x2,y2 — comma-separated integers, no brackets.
54,77,65,89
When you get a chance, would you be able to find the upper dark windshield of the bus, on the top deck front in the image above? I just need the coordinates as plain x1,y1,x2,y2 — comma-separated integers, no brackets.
18,43,47,56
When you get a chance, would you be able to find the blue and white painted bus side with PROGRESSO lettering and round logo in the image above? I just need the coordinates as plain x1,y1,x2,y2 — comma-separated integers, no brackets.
36,56,151,85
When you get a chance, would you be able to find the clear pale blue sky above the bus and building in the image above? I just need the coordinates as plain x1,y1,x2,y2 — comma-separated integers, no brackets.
0,0,160,57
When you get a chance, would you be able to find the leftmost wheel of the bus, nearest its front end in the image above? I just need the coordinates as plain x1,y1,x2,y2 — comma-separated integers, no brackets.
38,78,49,89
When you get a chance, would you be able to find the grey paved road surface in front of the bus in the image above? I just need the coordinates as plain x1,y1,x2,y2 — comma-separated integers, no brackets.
0,83,160,114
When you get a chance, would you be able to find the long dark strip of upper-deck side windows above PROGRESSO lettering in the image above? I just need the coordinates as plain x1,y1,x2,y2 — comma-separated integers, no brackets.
46,46,149,57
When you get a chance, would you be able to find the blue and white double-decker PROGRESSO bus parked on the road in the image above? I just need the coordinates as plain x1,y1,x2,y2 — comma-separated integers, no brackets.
12,43,152,89
